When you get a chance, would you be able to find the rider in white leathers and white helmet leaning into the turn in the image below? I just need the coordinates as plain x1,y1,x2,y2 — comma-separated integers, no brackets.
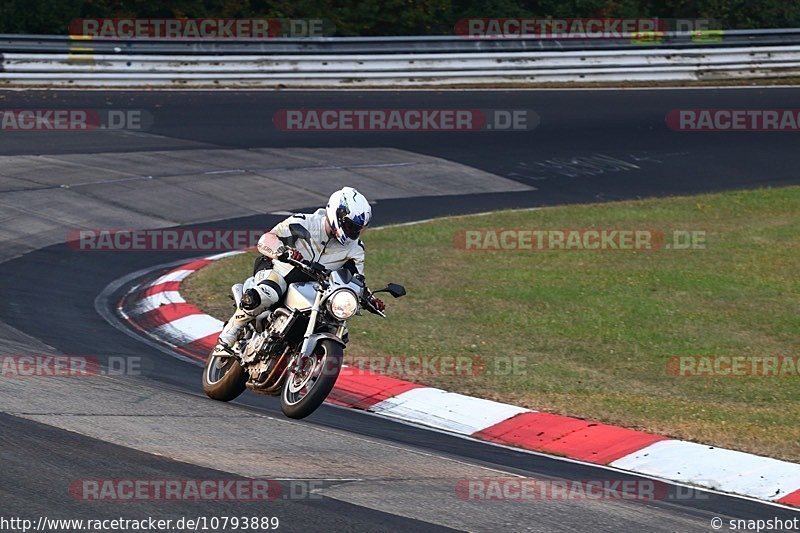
214,187,384,353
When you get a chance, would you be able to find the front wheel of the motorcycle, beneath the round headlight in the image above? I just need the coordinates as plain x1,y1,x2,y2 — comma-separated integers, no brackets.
281,339,344,419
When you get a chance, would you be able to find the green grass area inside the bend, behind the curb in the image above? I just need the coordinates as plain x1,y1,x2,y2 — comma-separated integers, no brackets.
182,187,800,461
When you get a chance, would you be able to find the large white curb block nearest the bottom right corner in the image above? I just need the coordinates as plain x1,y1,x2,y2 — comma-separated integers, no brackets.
611,440,800,500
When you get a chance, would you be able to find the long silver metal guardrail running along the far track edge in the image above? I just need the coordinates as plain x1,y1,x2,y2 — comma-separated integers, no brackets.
0,29,800,87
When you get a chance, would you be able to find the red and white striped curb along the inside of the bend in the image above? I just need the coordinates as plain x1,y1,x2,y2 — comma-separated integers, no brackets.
118,252,800,507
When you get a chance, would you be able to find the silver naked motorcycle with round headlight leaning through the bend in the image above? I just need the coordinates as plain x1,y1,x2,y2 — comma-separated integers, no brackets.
203,222,406,419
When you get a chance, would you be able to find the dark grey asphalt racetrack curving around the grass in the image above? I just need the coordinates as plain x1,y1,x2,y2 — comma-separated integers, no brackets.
0,88,800,531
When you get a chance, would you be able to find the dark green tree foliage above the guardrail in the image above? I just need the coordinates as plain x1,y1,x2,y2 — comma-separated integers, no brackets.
0,0,800,36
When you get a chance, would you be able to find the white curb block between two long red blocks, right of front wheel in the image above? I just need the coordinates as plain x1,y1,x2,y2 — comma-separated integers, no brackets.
369,388,529,435
